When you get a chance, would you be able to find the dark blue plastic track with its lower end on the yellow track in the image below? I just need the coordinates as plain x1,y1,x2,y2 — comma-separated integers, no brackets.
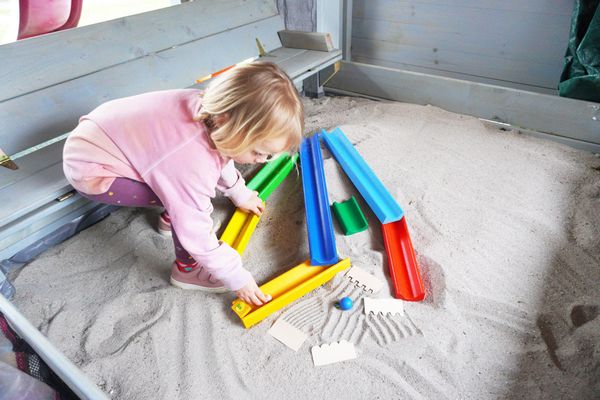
300,134,338,265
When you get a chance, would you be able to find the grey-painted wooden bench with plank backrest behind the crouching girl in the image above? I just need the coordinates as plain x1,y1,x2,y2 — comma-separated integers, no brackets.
0,0,342,260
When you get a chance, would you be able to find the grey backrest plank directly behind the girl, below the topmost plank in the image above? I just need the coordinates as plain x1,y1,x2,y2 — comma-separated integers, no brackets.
0,16,283,154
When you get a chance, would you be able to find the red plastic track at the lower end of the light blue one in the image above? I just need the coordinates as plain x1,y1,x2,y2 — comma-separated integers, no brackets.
381,218,425,301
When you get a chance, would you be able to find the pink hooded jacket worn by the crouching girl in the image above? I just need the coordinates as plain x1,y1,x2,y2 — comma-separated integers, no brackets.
63,89,252,290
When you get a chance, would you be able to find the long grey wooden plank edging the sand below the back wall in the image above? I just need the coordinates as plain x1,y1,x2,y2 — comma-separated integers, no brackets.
327,62,600,150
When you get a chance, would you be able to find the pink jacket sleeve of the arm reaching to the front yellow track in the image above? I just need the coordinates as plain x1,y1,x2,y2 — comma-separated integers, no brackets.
143,154,252,290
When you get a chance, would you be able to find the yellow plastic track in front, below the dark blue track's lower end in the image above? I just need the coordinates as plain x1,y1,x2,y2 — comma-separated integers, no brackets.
231,258,350,328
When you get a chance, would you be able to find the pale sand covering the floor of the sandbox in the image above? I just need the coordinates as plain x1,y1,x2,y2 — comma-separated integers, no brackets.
10,98,600,400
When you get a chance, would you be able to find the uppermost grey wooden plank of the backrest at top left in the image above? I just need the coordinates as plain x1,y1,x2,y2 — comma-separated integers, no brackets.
0,0,277,100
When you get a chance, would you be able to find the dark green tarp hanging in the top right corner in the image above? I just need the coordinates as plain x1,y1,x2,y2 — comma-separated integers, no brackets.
558,0,600,102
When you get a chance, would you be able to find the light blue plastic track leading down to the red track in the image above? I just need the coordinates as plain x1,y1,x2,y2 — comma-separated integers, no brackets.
322,128,404,224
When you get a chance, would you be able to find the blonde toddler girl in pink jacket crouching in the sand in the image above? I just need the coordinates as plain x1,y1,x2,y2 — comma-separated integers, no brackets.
63,62,304,305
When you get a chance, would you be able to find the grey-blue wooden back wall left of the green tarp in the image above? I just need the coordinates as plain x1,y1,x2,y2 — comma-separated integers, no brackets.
352,0,573,93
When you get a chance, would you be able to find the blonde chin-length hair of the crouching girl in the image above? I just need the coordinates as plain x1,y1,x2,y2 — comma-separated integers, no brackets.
196,62,304,157
